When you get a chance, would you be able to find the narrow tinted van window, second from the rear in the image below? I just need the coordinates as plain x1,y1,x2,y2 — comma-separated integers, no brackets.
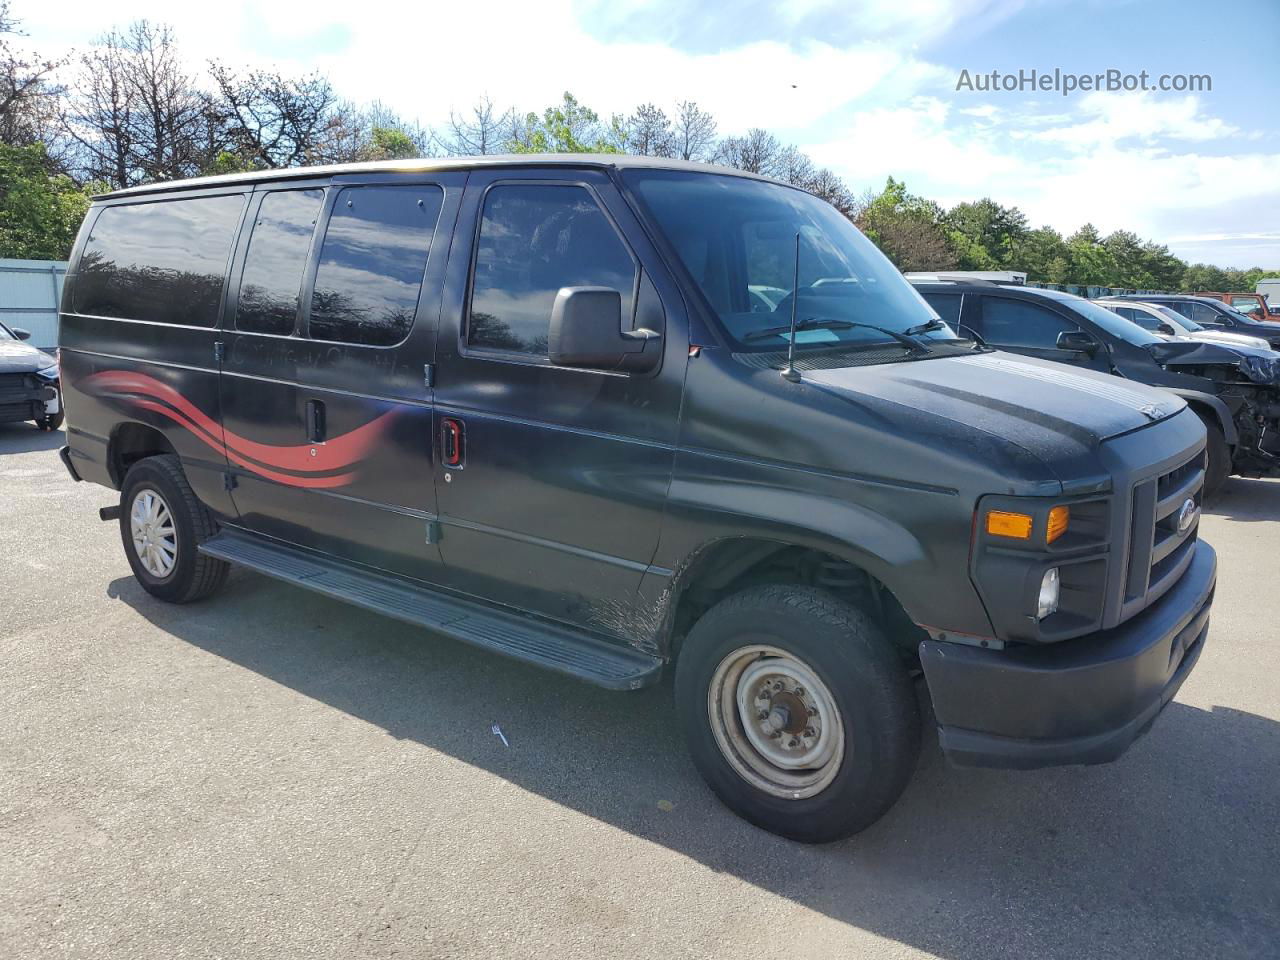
236,189,324,333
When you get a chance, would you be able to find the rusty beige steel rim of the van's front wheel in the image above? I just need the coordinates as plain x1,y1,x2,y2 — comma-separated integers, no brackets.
707,644,846,800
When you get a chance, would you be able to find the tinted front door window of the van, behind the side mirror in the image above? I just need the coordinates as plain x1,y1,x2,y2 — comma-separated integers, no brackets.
467,184,636,357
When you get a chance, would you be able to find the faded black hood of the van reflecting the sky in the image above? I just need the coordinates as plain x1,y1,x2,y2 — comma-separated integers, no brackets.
804,352,1185,458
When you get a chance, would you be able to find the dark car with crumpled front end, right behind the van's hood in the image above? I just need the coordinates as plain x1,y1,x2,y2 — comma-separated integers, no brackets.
916,283,1280,495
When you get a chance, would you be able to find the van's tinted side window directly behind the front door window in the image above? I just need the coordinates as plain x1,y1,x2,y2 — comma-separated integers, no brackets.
310,186,444,347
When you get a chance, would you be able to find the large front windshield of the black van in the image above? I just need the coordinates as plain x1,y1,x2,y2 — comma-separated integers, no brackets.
623,170,956,351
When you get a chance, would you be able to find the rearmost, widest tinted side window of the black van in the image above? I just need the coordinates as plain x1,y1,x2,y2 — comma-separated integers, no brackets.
74,196,244,326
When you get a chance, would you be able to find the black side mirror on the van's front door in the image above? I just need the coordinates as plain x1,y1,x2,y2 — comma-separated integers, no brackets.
547,287,662,372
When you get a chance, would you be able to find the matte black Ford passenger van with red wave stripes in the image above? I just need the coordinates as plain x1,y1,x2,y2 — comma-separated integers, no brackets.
61,156,1216,841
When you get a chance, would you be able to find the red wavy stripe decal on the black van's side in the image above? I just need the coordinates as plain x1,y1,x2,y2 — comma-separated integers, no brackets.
81,370,396,488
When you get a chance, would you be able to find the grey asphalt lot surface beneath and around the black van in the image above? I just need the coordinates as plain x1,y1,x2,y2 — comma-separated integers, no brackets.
0,425,1280,960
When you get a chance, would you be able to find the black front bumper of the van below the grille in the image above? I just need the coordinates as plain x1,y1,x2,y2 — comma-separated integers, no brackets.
920,541,1217,769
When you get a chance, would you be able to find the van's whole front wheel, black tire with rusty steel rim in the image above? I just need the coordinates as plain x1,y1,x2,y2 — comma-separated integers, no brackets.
676,585,920,844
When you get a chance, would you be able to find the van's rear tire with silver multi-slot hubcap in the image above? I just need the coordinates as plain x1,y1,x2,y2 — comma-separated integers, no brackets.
120,454,229,603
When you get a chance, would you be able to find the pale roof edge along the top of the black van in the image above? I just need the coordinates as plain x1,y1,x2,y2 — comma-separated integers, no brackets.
97,154,791,198
